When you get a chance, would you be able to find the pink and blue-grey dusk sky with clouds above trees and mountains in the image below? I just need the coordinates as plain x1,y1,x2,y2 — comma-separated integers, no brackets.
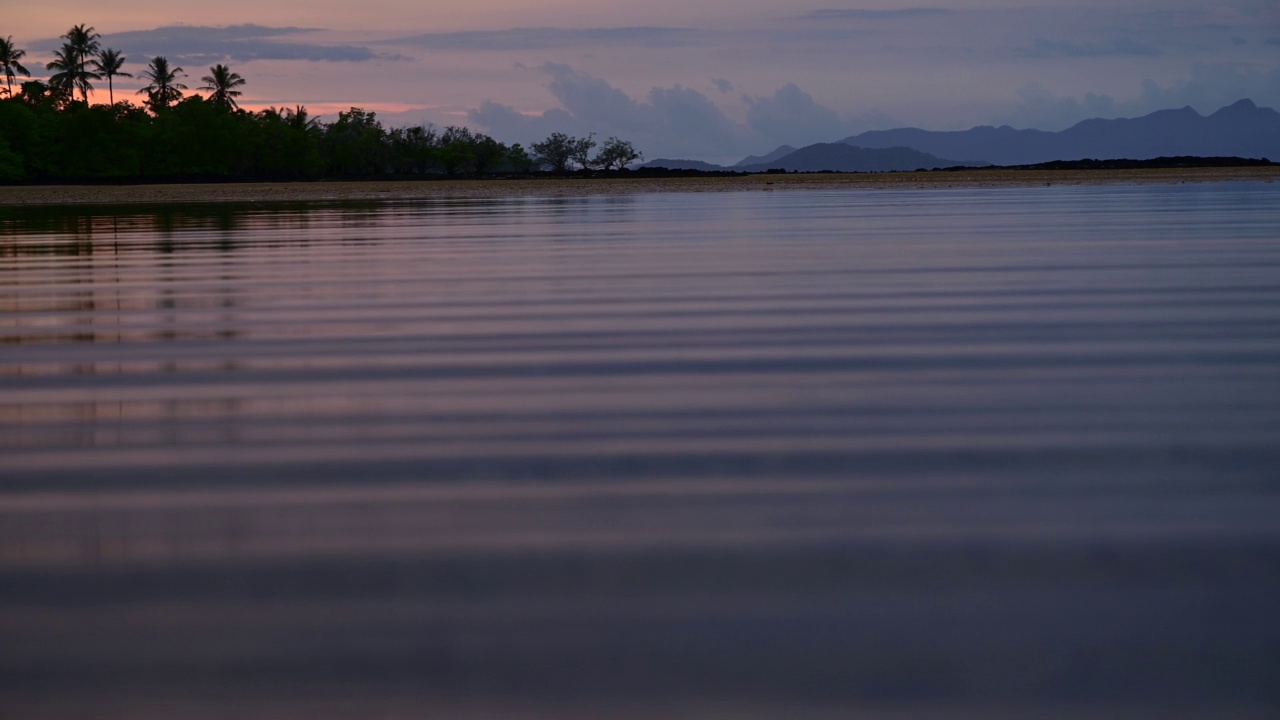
10,0,1280,163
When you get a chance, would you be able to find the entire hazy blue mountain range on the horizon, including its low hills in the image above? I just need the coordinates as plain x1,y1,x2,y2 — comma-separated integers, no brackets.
644,100,1280,172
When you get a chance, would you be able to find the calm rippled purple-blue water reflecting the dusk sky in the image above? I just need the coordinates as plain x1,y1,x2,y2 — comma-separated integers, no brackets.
0,183,1280,719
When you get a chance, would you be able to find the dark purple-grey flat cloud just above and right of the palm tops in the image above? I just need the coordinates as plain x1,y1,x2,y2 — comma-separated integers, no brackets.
87,24,403,64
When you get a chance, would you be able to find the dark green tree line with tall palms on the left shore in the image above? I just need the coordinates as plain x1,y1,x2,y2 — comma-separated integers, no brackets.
0,24,641,182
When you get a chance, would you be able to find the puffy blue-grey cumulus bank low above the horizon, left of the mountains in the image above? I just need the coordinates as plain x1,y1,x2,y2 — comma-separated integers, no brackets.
467,63,900,163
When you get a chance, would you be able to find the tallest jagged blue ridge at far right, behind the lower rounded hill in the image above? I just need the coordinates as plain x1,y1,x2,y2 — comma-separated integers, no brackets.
840,99,1280,165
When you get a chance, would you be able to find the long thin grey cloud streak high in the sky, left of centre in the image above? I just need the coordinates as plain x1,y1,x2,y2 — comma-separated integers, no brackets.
387,27,700,50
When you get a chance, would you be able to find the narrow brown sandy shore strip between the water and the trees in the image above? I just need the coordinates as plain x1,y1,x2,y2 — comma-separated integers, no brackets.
0,167,1280,206
